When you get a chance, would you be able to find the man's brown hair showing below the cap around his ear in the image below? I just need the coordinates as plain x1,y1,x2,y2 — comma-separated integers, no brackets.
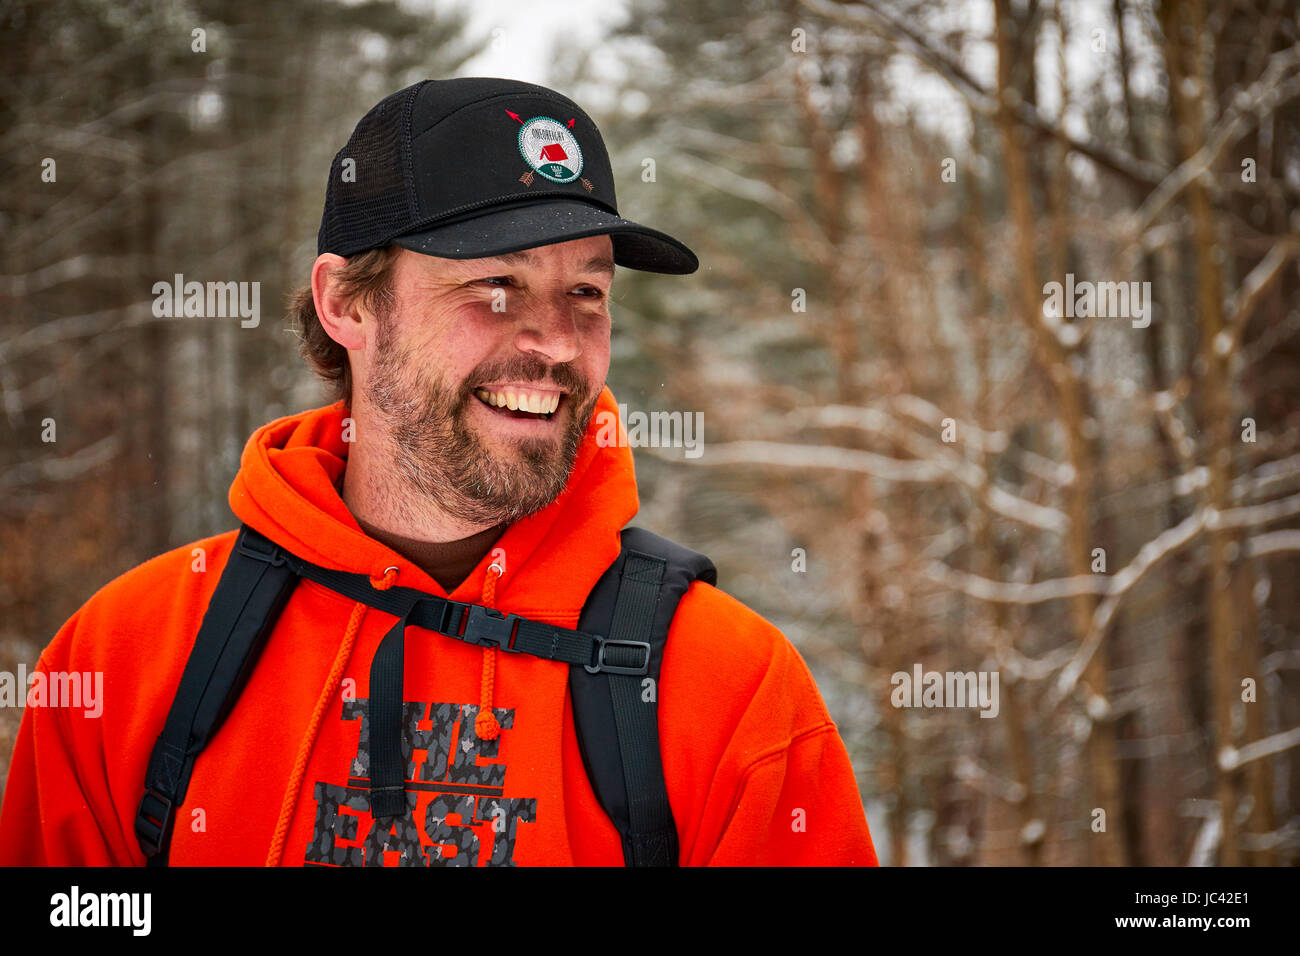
289,246,402,406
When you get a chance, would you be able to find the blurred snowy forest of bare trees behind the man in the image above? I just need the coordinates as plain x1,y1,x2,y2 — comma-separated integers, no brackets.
0,0,1300,865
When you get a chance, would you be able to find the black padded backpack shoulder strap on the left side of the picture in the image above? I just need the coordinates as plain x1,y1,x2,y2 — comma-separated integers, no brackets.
135,525,298,866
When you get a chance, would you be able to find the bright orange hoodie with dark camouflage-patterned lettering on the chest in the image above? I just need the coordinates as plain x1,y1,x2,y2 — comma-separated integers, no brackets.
0,389,876,866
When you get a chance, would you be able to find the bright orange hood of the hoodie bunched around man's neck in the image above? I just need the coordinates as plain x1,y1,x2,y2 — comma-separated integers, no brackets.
230,386,638,627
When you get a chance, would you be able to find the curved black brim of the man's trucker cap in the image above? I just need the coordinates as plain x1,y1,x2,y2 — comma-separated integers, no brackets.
393,199,699,276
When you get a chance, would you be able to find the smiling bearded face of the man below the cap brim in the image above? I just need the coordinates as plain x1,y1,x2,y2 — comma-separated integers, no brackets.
354,235,614,524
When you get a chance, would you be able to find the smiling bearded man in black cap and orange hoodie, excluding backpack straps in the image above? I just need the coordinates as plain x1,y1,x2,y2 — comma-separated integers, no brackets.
0,78,876,866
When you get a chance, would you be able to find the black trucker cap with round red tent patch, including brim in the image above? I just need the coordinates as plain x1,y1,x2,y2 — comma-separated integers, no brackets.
316,77,699,276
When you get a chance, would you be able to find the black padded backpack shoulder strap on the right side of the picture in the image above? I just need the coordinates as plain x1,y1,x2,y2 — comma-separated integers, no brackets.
569,528,718,866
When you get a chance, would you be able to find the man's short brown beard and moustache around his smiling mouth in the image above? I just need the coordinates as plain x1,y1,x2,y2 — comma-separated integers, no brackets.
365,310,601,524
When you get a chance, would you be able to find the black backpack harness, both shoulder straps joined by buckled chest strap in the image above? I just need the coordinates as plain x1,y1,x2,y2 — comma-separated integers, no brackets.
135,525,718,866
